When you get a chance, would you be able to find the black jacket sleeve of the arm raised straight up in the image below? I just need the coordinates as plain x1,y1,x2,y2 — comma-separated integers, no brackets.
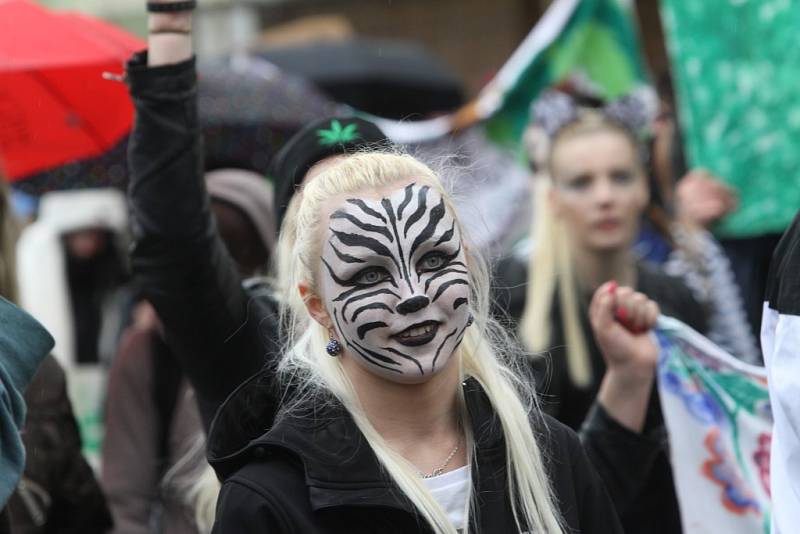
123,54,277,429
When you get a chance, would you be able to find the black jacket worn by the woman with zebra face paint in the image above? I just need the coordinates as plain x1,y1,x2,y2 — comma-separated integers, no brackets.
209,376,622,534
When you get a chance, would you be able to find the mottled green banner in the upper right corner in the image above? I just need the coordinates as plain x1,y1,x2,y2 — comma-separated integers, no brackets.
661,0,800,238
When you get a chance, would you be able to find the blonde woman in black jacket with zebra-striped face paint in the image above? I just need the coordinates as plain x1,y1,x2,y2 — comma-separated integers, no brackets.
205,152,620,534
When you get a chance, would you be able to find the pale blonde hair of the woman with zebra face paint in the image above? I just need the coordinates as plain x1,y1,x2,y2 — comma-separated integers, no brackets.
279,152,564,534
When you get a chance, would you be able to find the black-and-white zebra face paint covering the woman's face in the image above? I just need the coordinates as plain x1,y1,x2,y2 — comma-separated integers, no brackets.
321,184,469,383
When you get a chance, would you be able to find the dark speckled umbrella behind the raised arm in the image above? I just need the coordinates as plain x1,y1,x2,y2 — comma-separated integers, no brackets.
14,58,342,195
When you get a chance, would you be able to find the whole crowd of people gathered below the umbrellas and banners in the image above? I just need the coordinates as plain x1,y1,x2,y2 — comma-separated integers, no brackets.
0,0,797,534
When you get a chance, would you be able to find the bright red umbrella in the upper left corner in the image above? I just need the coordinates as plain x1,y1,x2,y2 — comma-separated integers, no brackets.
0,0,144,181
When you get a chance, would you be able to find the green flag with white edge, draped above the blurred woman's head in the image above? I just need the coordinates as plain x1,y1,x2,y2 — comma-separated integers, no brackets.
369,0,645,146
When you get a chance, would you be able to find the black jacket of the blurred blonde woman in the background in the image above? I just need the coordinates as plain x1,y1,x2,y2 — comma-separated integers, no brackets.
494,257,707,534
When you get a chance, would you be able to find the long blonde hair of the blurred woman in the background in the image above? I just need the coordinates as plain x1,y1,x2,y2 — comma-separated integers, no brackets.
519,110,638,387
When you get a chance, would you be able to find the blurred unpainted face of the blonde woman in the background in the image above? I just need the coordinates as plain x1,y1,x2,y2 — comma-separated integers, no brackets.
550,128,649,253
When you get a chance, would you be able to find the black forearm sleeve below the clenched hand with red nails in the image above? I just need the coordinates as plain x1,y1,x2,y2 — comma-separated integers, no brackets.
579,403,663,515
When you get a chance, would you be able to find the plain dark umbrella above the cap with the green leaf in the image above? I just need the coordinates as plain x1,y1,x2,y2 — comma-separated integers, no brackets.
257,38,464,119
